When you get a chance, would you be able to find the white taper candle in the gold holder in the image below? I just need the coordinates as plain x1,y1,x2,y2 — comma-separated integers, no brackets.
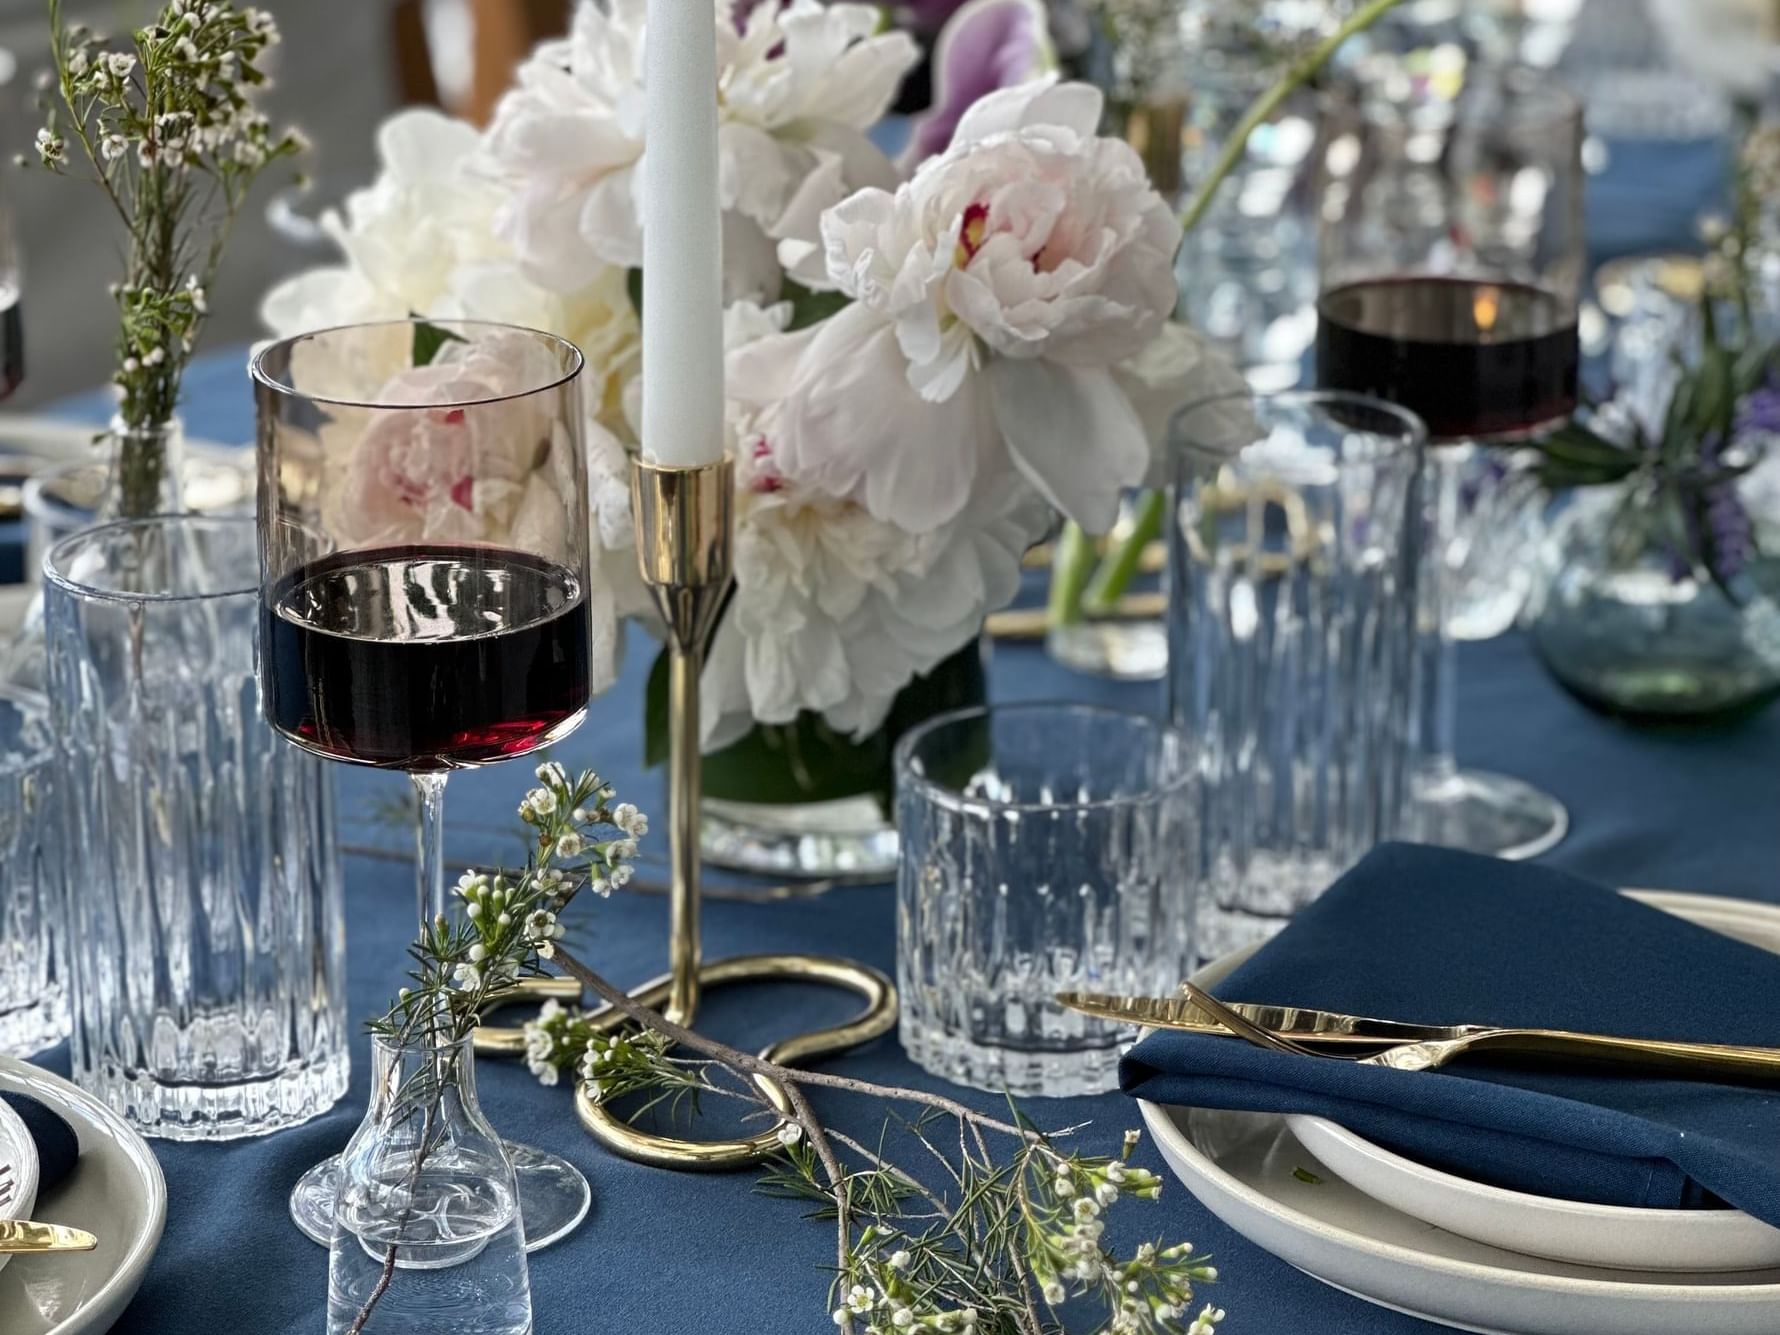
643,0,723,465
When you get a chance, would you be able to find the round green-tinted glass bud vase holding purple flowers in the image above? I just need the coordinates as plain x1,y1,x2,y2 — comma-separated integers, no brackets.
1527,477,1780,723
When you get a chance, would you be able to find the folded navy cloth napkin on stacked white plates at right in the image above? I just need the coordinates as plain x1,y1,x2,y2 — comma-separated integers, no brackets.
1120,844,1780,1226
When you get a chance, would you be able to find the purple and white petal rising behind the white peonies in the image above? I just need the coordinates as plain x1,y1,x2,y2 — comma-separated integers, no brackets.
904,0,1050,167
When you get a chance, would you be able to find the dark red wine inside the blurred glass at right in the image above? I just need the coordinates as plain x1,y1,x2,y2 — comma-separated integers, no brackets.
1317,276,1581,440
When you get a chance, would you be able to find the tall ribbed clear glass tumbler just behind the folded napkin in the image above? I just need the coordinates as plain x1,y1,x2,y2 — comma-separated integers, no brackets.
1168,392,1422,959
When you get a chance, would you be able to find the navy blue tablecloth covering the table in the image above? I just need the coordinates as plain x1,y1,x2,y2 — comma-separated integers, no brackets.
27,130,1780,1335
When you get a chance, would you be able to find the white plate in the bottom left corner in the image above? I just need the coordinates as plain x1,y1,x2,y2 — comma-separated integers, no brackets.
0,1057,167,1335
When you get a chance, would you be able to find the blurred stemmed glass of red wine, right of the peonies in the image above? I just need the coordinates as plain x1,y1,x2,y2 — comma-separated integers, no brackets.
1317,71,1584,858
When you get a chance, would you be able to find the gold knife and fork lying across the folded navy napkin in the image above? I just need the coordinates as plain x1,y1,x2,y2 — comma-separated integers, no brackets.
1057,988,1780,1082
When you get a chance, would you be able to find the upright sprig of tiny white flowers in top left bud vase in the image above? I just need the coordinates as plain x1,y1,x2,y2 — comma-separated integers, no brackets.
36,0,304,516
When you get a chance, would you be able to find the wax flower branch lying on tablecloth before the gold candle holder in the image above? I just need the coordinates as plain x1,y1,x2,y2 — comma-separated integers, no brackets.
525,958,1225,1335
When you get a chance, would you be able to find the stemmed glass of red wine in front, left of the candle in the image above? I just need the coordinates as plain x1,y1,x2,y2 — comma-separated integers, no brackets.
253,320,591,1250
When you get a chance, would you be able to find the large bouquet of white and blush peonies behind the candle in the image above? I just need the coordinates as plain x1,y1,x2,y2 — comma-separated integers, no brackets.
263,0,1221,865
